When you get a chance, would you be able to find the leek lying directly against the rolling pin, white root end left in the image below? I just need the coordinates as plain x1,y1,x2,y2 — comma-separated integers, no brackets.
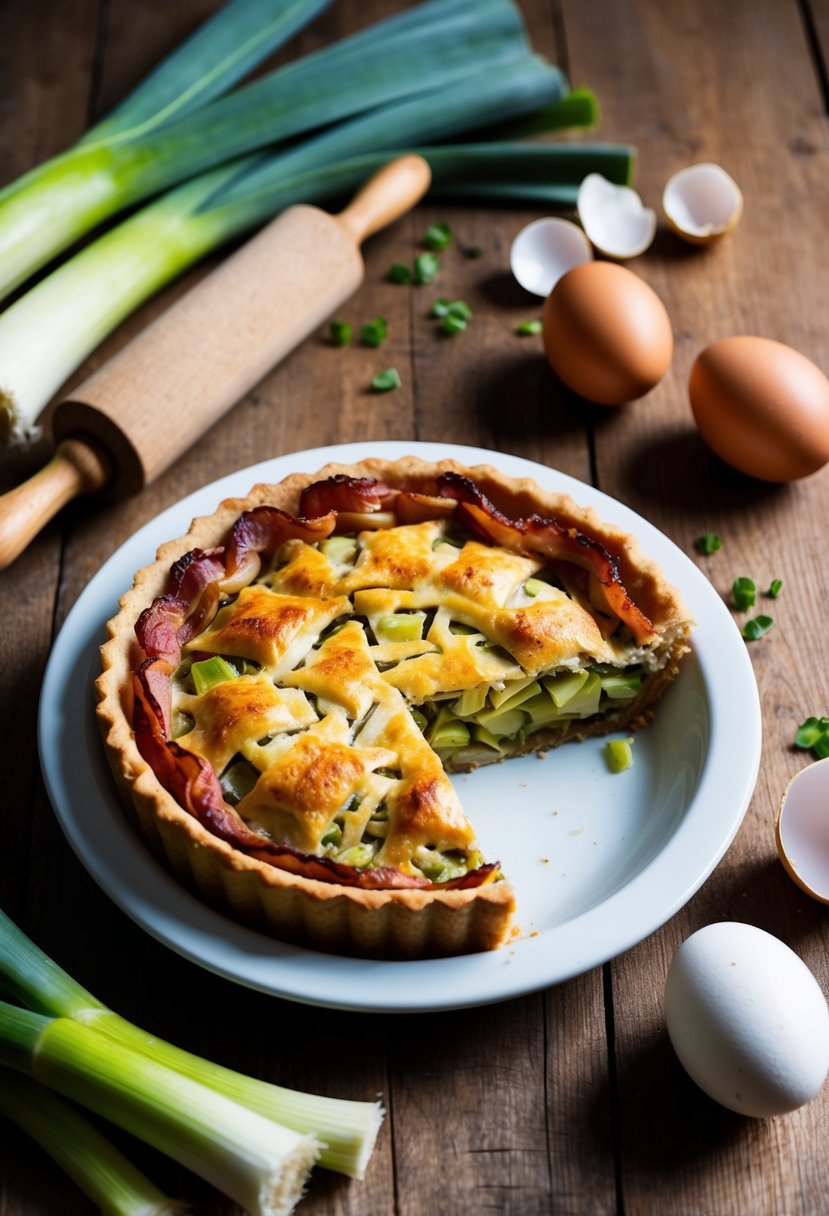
0,105,633,440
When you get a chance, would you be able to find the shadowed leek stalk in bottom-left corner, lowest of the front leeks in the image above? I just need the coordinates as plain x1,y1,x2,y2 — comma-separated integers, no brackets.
0,1070,185,1216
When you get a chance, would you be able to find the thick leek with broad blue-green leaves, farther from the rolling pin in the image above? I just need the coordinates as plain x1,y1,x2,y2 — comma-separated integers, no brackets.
0,0,534,298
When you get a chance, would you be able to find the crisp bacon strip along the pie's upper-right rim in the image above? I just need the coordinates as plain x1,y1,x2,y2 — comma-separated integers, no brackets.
438,473,655,646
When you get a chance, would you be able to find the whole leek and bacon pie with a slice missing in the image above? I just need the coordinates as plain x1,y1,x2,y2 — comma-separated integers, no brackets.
96,458,689,957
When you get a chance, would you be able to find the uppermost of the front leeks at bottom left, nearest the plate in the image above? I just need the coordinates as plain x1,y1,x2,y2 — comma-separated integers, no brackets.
0,911,383,1178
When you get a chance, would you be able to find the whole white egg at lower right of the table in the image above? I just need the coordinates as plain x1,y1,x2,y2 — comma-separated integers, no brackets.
665,921,829,1119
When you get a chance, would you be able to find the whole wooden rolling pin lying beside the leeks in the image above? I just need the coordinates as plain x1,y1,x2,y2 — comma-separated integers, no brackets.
0,156,430,569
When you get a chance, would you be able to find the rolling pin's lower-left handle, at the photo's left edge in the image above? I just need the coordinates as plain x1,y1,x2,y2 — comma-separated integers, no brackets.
0,438,111,569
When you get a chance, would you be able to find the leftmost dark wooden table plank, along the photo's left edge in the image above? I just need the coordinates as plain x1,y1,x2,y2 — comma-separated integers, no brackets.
0,0,114,1216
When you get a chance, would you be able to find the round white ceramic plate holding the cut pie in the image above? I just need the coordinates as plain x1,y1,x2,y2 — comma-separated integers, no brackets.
39,443,761,1012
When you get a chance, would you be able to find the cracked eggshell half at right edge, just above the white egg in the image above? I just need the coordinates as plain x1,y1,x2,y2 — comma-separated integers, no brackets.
774,758,829,903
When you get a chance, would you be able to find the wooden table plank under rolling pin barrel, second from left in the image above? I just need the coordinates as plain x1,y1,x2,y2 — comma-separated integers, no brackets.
38,5,412,1216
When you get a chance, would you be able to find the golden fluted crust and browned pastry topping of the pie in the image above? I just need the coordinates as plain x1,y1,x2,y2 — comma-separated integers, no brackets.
96,457,689,958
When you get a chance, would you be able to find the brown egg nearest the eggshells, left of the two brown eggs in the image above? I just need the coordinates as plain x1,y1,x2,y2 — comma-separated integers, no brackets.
542,261,673,405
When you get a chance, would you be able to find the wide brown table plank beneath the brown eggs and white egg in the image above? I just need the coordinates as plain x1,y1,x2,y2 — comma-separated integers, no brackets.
564,2,829,1214
